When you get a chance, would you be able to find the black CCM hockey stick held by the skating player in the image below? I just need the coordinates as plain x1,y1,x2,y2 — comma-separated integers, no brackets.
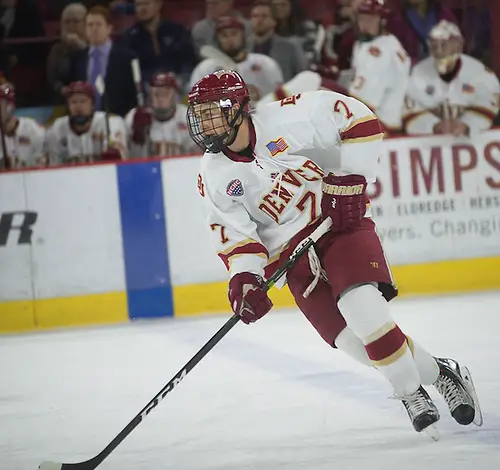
38,218,332,470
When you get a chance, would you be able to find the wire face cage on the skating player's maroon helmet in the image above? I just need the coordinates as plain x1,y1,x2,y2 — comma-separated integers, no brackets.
187,99,246,153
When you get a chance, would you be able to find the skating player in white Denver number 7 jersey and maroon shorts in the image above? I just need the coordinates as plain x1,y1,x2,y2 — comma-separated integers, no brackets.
187,71,481,431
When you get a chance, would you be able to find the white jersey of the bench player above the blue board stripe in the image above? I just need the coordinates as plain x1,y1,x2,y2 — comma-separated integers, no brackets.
125,104,199,158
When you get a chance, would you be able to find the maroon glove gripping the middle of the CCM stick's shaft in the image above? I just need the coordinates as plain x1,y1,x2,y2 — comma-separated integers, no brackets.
228,273,273,325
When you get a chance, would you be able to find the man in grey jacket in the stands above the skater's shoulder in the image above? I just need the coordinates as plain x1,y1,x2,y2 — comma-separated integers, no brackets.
250,0,307,82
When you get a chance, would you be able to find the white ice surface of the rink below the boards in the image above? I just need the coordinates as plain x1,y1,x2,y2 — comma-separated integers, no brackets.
0,293,500,470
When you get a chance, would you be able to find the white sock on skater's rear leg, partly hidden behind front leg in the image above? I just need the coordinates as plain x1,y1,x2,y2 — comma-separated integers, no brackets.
335,327,439,385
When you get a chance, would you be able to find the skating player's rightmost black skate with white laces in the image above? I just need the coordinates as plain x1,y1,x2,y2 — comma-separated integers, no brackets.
434,358,483,426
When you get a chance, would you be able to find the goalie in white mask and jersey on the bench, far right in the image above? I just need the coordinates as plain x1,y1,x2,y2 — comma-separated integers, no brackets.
404,20,500,136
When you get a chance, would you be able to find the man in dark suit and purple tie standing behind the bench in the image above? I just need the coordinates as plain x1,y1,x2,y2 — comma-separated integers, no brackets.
70,5,137,116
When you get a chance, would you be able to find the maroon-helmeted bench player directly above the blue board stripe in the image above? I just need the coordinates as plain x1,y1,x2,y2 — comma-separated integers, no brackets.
125,72,196,157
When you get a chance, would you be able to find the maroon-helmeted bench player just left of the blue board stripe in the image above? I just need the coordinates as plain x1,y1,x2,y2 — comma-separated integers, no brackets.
47,82,127,165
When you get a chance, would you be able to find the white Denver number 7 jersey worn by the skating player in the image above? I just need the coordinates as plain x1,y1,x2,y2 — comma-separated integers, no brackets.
198,91,384,276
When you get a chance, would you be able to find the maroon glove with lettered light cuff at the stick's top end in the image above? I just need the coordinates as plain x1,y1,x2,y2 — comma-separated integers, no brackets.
321,173,367,233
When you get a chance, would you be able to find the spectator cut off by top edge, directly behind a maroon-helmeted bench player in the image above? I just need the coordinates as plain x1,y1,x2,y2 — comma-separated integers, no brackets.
191,0,252,54
